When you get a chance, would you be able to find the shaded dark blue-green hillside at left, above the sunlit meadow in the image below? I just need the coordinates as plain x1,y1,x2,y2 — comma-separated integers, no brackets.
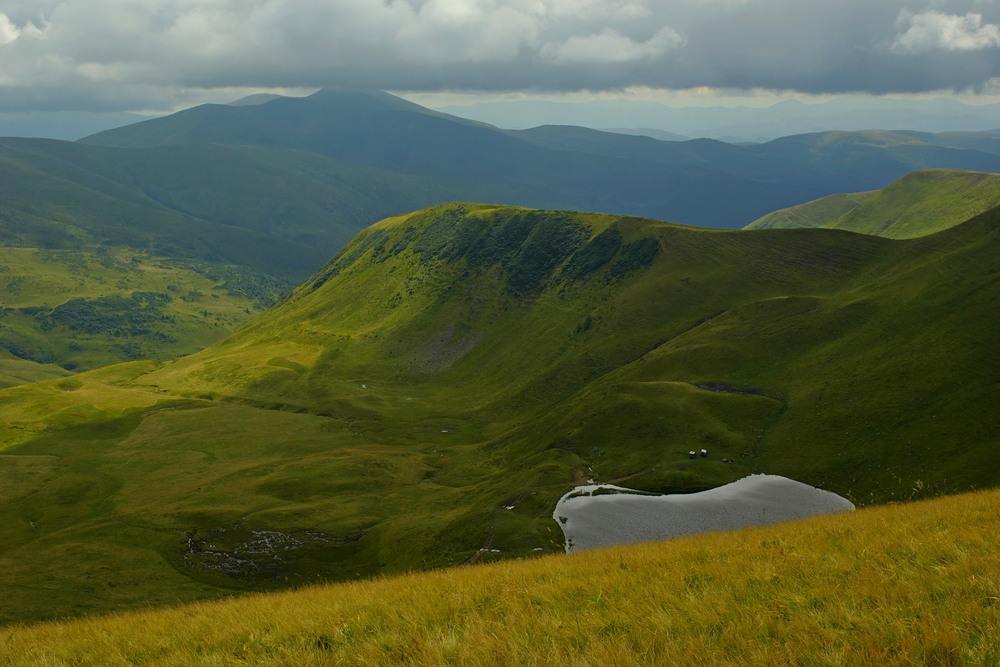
0,139,468,281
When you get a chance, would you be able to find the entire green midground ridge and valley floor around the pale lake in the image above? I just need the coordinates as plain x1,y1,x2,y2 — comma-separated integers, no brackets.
0,204,1000,620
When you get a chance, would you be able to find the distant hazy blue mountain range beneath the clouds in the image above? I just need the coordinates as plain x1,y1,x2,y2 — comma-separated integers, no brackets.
82,90,1000,228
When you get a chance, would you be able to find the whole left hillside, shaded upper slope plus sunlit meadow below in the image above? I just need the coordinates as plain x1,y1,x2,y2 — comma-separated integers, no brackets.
0,139,486,374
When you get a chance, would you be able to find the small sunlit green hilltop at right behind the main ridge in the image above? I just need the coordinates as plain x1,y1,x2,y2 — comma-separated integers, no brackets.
746,169,1000,239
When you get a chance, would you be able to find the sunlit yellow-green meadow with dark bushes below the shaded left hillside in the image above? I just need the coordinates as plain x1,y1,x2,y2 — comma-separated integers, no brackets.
0,246,286,374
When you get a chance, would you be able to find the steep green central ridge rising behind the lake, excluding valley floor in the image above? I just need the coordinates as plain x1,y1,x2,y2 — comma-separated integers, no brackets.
144,201,997,500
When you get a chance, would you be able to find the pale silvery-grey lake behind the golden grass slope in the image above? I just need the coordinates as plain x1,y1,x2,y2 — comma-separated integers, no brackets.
552,475,854,553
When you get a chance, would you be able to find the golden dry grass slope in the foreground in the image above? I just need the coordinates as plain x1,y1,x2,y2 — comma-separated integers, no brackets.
0,491,1000,665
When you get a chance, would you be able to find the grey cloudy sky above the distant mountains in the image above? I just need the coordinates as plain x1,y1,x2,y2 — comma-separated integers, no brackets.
0,0,1000,111
